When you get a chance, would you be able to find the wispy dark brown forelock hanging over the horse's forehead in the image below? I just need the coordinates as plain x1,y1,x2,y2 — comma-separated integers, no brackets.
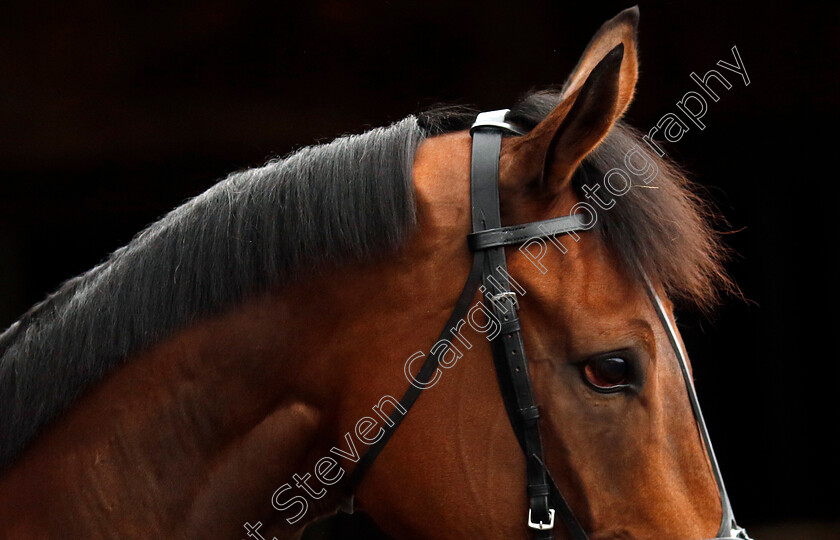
507,90,737,311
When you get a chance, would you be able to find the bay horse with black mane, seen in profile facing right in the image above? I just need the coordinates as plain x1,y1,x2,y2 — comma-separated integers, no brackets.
0,8,746,539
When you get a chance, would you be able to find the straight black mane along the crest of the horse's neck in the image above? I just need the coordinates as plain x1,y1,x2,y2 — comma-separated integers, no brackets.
0,117,425,467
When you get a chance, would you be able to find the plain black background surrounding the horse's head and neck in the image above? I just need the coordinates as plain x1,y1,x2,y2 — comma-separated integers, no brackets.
0,0,840,538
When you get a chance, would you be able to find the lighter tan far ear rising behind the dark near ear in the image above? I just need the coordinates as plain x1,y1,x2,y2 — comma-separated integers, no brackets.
560,6,639,116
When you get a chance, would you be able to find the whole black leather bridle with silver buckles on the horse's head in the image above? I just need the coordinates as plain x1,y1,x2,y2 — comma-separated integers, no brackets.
346,109,749,540
